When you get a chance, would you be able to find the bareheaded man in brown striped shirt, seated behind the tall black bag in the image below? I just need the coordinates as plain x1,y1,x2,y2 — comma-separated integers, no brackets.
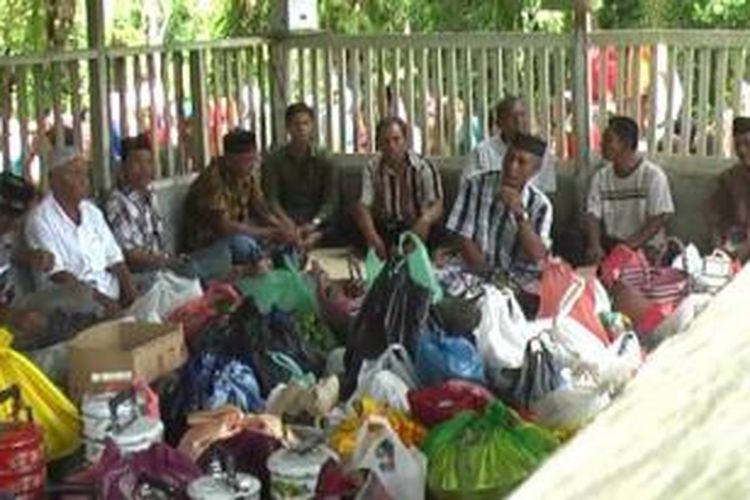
354,117,443,259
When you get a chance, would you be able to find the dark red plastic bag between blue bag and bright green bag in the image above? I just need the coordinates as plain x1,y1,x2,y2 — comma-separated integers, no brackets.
407,380,495,427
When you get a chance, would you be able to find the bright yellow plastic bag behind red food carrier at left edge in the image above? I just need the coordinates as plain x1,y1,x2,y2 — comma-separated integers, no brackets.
0,328,81,460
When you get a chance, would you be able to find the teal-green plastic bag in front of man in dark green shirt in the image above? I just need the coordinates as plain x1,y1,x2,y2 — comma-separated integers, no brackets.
238,256,318,314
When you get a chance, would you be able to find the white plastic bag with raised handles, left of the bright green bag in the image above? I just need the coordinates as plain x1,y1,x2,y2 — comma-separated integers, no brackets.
351,417,427,500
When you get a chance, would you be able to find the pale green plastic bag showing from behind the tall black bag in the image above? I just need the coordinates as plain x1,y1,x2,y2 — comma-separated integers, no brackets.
365,231,443,304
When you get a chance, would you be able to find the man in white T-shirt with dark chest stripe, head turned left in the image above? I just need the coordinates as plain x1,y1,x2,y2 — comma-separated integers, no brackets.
586,116,674,263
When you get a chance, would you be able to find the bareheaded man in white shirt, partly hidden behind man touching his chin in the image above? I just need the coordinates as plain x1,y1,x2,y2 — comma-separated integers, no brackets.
461,95,557,193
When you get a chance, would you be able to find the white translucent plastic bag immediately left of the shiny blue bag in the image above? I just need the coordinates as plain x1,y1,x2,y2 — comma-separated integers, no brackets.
349,344,419,412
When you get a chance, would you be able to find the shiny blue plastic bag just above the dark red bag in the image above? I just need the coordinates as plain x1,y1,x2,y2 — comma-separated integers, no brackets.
416,333,484,386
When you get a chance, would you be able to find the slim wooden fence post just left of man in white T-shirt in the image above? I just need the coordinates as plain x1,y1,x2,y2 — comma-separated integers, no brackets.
573,0,591,170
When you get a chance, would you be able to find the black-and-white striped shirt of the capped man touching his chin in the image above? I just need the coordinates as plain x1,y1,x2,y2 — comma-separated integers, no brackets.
447,171,552,285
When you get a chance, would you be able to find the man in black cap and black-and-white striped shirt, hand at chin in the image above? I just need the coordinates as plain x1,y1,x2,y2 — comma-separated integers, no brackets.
448,134,552,290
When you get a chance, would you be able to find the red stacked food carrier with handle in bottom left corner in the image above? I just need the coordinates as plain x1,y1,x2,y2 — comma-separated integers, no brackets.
0,385,46,500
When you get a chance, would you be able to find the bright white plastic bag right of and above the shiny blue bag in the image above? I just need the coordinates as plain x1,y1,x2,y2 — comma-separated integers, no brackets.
474,286,533,371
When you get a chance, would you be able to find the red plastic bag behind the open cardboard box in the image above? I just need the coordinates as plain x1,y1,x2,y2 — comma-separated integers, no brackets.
169,282,242,342
